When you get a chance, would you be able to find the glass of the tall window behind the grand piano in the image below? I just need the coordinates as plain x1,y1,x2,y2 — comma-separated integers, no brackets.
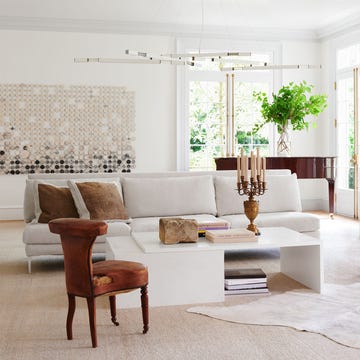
185,49,273,170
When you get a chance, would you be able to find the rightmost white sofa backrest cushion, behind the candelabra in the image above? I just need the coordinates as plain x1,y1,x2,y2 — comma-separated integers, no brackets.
214,174,301,216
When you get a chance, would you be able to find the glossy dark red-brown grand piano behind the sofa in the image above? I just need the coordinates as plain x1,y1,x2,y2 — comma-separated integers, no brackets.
215,156,335,214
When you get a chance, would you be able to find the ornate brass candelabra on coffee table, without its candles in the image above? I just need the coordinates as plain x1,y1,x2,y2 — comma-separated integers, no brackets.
237,176,266,235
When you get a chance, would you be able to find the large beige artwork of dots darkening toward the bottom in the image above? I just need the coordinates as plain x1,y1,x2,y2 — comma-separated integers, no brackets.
0,84,135,174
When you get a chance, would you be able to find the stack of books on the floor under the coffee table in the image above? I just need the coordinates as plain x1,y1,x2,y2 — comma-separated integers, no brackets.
225,268,269,295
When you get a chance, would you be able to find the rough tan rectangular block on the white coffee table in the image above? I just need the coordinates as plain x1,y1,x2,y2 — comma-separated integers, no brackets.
159,218,198,244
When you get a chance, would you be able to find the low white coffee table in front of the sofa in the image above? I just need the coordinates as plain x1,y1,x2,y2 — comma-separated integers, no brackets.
106,227,323,307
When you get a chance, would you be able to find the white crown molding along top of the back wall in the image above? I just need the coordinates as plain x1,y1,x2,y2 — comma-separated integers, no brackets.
0,16,317,41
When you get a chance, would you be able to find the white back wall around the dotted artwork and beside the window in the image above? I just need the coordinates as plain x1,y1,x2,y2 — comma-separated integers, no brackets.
0,30,329,219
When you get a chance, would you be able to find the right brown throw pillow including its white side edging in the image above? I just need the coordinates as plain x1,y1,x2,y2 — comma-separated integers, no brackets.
68,180,129,220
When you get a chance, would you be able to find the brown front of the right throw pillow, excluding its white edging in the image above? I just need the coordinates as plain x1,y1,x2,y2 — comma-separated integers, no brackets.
76,182,129,220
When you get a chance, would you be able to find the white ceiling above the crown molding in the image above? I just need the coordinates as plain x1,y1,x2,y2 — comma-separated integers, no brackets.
0,0,360,39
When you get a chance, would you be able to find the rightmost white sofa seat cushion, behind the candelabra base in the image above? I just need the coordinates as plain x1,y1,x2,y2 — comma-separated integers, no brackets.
221,211,320,232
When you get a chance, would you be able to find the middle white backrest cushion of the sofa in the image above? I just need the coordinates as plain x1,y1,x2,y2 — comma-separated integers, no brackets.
122,175,216,218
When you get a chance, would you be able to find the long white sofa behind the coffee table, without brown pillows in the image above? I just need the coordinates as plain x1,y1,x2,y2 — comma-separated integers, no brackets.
23,170,320,272
